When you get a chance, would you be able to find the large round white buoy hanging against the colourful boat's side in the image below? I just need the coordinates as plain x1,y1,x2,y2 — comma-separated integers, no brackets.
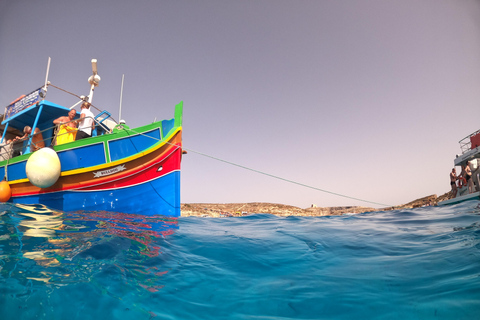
25,148,61,188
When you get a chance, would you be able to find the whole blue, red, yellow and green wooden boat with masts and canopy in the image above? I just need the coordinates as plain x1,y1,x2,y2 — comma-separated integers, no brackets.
0,60,183,217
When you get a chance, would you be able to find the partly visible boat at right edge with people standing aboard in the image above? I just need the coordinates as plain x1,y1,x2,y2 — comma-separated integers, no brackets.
438,130,480,205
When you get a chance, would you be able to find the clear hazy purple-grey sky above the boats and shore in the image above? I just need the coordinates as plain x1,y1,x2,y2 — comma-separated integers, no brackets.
0,0,480,208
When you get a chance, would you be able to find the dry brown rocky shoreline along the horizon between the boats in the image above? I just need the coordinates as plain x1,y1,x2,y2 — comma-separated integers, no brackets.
181,192,450,218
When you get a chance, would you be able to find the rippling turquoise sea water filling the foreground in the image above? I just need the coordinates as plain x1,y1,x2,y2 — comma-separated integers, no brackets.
0,201,480,320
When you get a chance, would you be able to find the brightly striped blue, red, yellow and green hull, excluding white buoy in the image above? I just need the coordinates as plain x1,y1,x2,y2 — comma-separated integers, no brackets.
0,99,182,217
